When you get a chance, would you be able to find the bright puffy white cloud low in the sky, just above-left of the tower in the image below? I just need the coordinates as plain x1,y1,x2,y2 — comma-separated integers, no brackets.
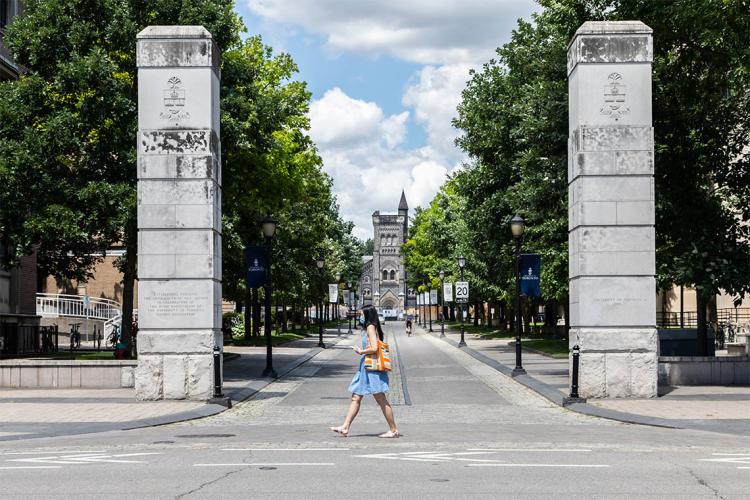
310,88,452,239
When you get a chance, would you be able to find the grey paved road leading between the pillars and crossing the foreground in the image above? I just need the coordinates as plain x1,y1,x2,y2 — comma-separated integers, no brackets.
0,325,750,499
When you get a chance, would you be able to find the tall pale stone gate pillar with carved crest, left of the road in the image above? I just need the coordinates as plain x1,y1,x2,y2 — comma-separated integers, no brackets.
135,26,222,400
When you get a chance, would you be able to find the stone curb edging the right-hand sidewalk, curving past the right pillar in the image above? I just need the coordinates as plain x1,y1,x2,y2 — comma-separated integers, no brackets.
420,327,700,435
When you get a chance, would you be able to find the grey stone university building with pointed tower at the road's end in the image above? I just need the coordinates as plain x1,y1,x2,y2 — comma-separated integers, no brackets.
359,191,415,318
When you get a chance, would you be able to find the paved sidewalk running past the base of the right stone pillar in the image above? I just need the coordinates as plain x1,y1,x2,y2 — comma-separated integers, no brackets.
417,323,750,436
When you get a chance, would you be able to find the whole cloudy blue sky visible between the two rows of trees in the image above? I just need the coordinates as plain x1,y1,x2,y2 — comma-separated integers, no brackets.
236,0,536,238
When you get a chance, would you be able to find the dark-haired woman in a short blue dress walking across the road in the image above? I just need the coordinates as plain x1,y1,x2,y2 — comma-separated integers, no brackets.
331,306,401,438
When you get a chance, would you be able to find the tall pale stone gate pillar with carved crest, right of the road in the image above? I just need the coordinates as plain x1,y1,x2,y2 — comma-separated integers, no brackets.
568,21,658,398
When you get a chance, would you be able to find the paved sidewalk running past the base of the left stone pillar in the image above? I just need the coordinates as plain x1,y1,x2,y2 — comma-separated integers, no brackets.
0,328,347,441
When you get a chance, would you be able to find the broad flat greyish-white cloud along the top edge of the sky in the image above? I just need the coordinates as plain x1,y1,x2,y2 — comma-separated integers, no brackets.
247,0,533,64
